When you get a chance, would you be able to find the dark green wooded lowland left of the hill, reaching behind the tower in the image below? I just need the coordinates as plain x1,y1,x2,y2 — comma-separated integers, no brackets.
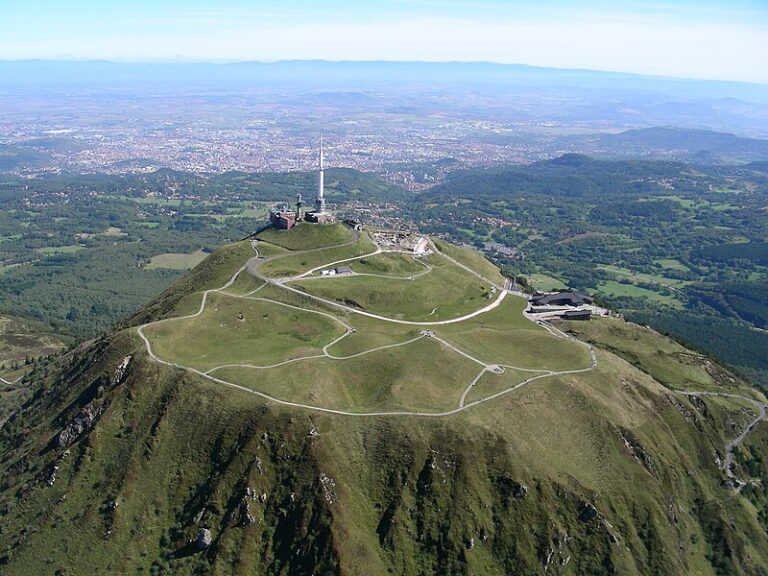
0,170,403,337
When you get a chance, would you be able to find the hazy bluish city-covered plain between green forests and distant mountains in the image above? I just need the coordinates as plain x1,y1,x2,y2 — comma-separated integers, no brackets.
0,63,768,190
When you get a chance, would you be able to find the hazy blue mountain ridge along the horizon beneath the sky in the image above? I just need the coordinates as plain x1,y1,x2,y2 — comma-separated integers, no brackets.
0,60,768,102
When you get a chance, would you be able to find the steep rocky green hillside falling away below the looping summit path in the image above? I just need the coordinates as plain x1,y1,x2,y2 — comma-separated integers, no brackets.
0,235,768,575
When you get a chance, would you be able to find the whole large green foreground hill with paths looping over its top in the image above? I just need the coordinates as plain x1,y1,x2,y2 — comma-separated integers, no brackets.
0,225,768,575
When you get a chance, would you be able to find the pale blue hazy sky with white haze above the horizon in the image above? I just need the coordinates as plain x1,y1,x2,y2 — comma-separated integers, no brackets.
0,0,768,83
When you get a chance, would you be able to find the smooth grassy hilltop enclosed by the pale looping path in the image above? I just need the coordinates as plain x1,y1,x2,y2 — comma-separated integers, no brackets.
145,228,604,411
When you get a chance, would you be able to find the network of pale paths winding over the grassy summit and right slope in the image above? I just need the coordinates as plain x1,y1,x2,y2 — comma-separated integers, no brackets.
137,231,766,491
